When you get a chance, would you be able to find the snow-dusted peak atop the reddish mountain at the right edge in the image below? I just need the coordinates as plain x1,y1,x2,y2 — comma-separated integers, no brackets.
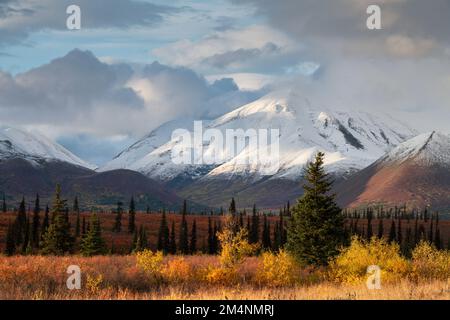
381,131,450,166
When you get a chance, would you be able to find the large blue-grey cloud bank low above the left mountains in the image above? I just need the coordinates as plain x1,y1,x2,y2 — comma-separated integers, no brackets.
0,49,254,162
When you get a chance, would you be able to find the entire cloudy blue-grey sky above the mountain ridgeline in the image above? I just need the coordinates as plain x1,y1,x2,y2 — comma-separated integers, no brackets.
0,0,450,165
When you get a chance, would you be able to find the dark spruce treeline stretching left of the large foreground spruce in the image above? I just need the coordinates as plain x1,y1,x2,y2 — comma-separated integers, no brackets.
1,186,291,256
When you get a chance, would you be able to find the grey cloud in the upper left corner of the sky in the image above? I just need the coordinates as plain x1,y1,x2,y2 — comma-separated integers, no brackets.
0,0,179,45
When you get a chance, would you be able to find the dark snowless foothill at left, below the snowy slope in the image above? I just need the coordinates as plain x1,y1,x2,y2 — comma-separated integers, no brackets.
0,158,188,210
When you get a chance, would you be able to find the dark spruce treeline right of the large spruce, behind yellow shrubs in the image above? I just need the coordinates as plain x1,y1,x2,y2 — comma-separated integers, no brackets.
344,206,450,257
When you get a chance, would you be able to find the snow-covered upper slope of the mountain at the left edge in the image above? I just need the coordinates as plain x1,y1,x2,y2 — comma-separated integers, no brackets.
0,126,96,169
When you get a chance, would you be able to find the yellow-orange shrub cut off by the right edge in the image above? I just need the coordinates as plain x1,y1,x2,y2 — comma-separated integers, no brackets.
411,241,450,280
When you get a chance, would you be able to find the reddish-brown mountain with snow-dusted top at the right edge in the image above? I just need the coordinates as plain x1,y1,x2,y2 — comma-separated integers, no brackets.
336,132,450,209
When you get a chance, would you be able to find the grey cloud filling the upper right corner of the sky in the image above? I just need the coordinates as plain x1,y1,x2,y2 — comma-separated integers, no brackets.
234,0,450,58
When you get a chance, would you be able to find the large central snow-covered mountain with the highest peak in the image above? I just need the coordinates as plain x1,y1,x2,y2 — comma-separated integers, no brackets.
101,89,416,206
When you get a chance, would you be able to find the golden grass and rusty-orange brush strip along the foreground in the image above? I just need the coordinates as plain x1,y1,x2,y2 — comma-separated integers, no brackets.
0,255,450,300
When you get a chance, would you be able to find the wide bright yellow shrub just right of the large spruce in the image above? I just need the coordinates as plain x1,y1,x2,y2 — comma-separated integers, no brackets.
329,237,409,284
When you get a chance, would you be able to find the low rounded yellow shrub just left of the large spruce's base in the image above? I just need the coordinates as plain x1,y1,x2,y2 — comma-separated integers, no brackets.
256,250,298,286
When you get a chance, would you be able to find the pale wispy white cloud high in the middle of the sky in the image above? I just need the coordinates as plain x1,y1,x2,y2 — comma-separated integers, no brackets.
152,25,302,74
